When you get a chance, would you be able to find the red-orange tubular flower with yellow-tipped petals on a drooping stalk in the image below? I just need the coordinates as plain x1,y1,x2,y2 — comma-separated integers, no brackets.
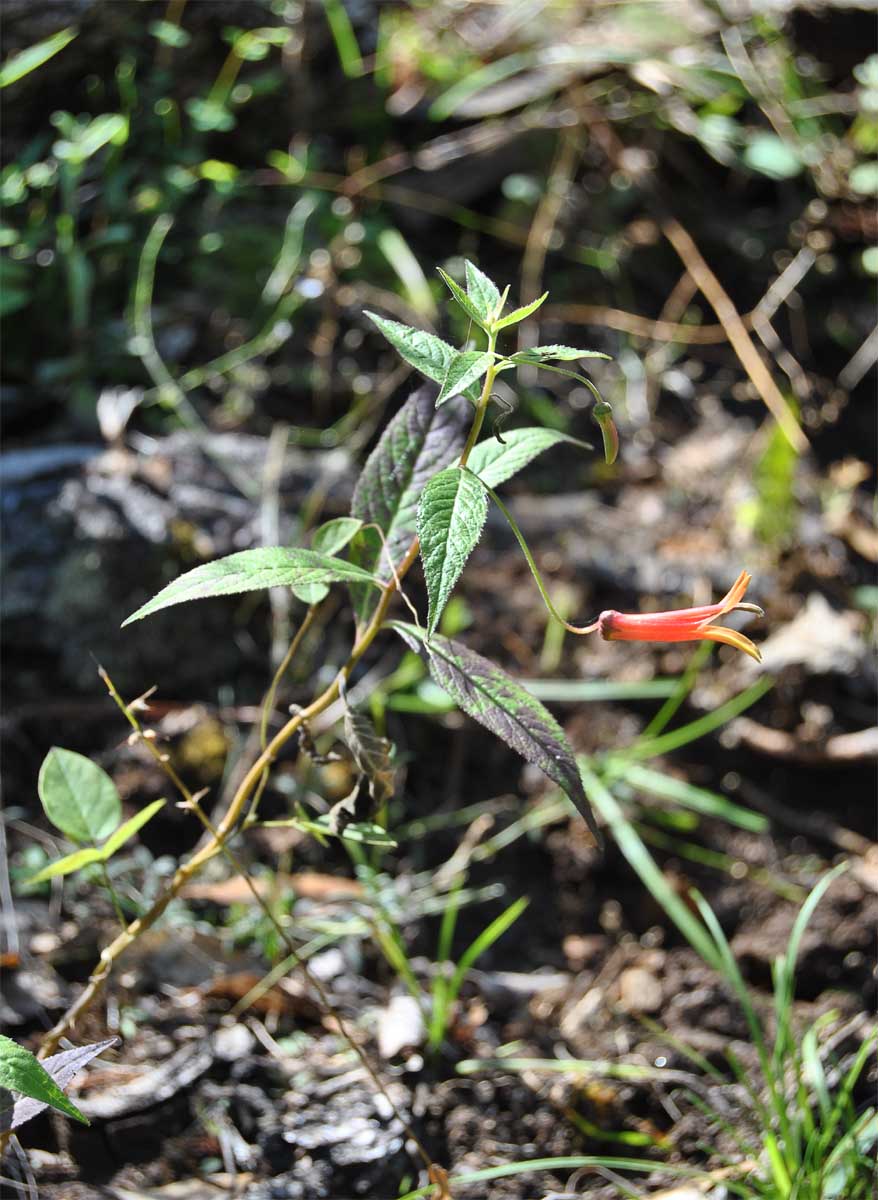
591,571,763,662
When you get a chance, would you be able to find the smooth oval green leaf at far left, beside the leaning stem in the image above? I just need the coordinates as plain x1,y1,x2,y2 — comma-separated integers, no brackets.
38,746,122,842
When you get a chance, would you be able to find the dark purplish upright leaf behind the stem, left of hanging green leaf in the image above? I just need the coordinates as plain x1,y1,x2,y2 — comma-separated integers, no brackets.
350,388,470,622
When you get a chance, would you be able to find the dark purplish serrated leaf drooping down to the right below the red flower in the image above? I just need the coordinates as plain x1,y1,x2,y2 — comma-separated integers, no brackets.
390,620,601,845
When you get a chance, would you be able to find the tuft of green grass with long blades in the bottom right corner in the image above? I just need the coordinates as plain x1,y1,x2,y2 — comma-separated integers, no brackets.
575,767,878,1200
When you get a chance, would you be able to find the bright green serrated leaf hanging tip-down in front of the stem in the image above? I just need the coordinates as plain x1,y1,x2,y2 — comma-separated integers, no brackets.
417,467,488,637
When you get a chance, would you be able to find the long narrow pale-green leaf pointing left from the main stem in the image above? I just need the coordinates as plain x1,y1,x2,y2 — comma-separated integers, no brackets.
122,546,375,626
